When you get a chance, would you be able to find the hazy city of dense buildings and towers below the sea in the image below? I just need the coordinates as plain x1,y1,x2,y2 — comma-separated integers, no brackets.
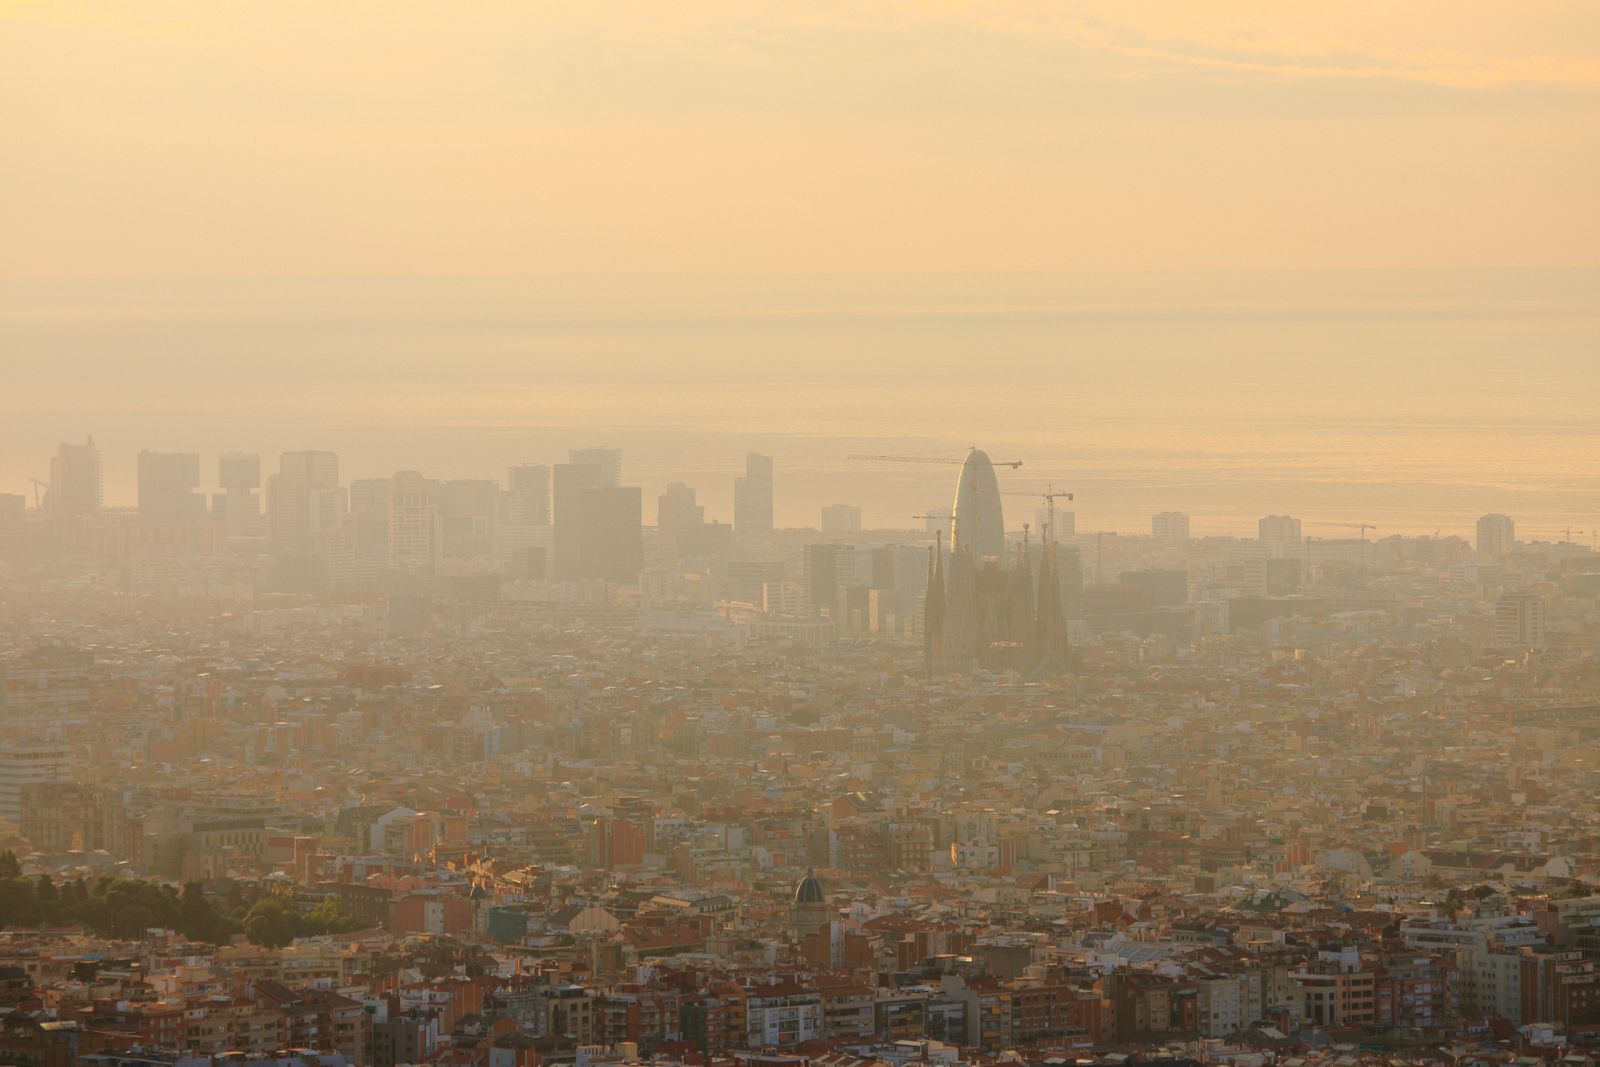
0,440,1600,1067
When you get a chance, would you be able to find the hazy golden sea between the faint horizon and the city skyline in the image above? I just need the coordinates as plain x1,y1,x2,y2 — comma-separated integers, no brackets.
0,270,1600,542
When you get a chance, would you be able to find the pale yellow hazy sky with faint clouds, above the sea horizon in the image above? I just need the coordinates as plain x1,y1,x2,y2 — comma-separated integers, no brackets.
0,0,1600,282
